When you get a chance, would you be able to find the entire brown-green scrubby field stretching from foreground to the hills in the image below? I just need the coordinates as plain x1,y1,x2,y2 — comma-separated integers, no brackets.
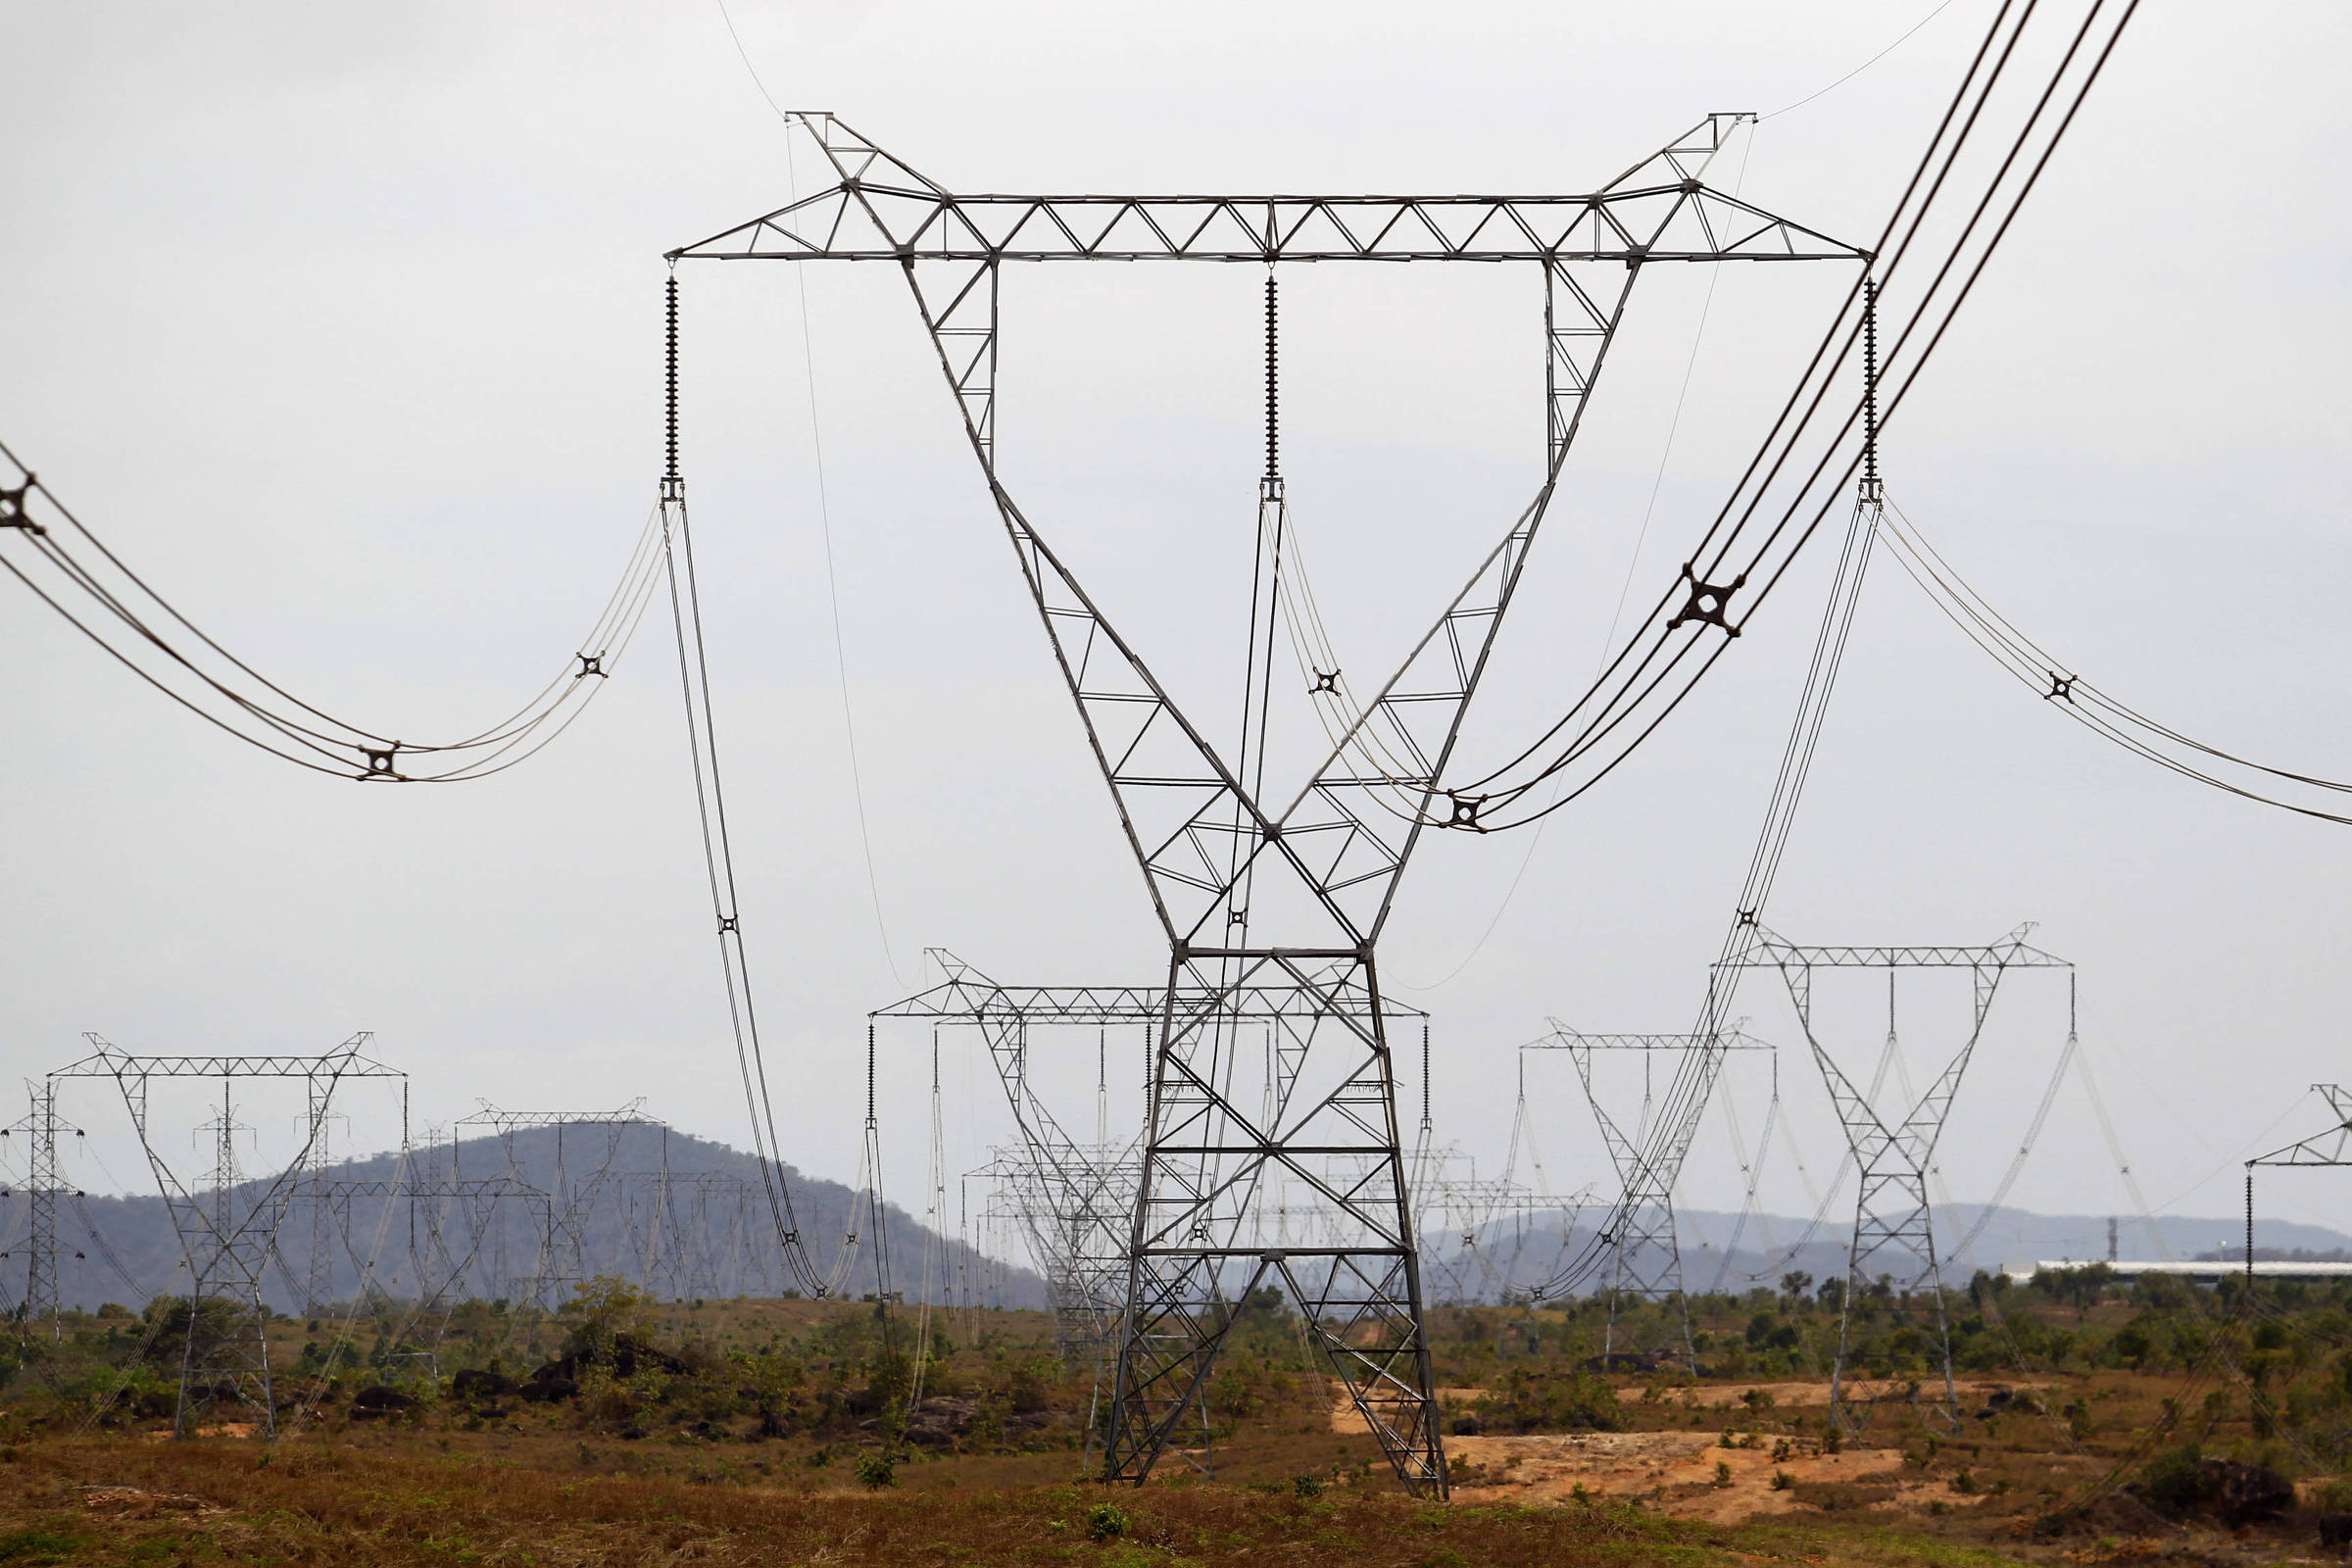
0,1277,2352,1568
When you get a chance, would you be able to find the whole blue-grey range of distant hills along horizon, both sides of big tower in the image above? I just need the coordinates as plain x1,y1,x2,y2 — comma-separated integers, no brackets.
14,1124,2352,1312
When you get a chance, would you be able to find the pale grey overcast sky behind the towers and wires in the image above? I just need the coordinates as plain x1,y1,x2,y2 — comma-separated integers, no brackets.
0,0,2352,1259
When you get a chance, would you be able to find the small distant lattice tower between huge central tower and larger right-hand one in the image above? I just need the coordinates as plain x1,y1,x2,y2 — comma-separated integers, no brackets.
1519,1018,1771,1375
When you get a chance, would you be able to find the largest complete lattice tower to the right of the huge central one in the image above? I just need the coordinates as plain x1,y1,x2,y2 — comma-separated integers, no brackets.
1740,921,2075,1425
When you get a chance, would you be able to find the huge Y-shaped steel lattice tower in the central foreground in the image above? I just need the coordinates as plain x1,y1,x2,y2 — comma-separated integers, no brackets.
665,113,1863,1495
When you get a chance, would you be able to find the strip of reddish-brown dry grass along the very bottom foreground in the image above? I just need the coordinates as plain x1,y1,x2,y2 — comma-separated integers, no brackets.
0,1439,2041,1568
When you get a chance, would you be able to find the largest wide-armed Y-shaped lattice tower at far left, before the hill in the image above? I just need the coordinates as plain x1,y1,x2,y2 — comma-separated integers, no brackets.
49,1030,407,1437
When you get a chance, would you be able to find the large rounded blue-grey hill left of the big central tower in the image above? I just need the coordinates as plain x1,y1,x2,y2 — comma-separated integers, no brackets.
0,1124,1045,1312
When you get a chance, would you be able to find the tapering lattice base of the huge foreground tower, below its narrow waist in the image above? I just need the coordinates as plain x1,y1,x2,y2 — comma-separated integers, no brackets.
1103,950,1446,1497
